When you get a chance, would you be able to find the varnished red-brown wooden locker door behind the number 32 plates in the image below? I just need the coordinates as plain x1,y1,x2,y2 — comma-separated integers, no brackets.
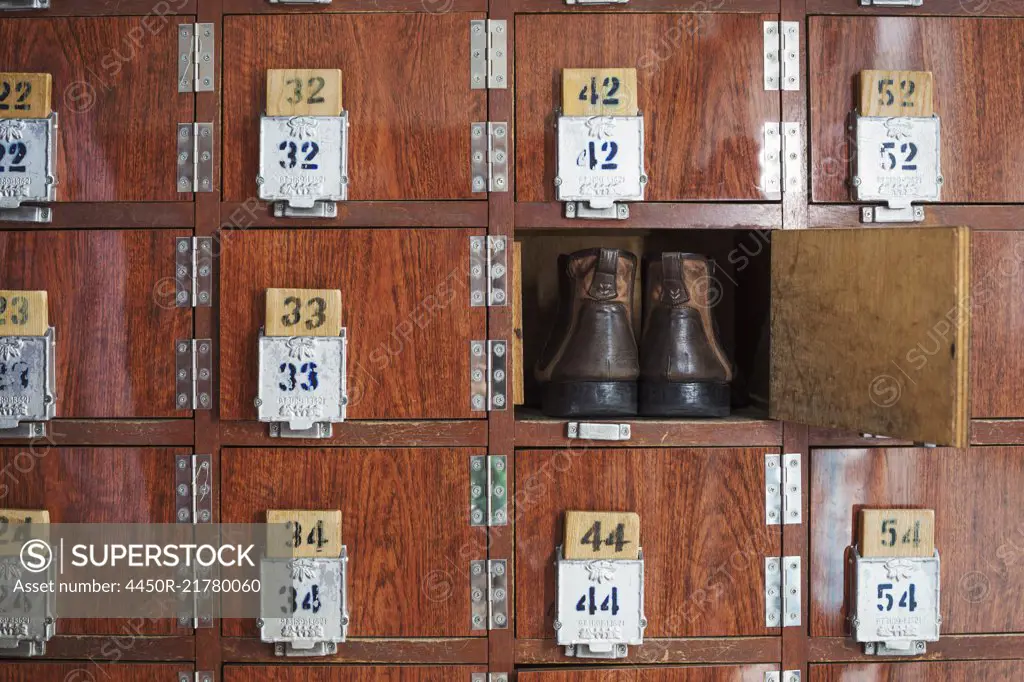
223,12,486,201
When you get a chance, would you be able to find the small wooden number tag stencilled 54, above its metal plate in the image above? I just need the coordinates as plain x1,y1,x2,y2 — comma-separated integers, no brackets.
859,509,935,557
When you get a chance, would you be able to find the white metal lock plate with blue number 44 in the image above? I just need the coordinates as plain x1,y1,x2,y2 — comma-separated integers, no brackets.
555,547,647,658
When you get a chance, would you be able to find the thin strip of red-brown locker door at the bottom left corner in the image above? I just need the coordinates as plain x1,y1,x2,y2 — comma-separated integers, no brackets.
0,658,193,682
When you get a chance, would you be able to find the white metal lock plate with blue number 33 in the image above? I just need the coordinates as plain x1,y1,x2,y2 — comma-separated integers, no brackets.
256,329,348,438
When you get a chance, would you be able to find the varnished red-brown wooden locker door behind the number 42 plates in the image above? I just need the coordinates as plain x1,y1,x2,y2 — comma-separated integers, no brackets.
515,12,779,202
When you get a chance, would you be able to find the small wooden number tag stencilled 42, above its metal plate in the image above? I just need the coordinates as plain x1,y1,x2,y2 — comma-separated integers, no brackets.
562,69,638,116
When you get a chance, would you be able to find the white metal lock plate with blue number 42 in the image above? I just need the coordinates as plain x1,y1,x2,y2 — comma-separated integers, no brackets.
555,116,647,217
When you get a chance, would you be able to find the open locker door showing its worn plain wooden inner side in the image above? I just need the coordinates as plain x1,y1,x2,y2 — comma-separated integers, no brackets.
769,227,971,447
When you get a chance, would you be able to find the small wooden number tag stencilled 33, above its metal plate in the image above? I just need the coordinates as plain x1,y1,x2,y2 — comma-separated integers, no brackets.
264,289,341,336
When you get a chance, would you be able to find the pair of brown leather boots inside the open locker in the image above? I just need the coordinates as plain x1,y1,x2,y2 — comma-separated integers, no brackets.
535,249,732,417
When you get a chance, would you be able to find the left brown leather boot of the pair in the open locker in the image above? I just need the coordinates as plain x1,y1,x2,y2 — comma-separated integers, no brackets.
535,244,640,417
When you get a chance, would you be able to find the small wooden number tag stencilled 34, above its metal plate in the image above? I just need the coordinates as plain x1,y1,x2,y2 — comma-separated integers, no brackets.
266,509,341,558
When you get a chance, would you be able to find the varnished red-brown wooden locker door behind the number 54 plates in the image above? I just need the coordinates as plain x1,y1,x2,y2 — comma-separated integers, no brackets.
810,447,1024,634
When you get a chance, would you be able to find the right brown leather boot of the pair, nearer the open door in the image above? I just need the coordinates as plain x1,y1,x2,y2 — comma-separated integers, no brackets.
639,253,732,417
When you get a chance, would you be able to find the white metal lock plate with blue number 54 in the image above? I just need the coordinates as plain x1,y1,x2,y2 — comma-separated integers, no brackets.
851,547,942,655
